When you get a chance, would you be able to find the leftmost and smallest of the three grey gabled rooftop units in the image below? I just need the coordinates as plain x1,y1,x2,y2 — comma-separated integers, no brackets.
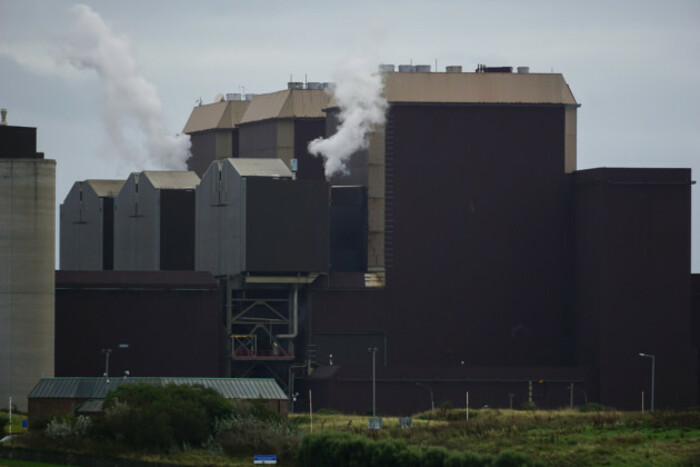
60,180,124,271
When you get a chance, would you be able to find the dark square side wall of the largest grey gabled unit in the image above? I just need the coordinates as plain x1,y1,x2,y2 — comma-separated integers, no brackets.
245,177,330,272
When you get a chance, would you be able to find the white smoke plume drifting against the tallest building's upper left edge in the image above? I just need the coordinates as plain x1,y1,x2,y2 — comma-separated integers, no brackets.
308,57,387,177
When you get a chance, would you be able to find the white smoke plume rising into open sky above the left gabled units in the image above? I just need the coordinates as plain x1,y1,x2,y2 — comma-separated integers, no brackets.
63,4,191,170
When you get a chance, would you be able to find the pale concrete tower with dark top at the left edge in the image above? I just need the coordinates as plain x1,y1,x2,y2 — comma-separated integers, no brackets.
0,113,56,411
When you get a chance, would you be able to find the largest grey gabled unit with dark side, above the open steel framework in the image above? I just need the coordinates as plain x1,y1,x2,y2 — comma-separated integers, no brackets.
196,159,329,276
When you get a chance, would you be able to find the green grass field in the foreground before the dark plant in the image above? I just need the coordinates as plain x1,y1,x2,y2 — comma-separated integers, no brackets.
0,409,700,466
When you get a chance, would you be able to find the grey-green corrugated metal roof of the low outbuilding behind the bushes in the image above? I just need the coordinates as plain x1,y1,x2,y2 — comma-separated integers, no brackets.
27,377,287,399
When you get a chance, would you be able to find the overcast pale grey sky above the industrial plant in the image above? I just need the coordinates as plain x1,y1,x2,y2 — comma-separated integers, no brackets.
0,0,700,272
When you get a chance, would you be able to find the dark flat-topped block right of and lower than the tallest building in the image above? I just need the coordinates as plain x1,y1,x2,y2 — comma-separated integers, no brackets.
575,168,697,409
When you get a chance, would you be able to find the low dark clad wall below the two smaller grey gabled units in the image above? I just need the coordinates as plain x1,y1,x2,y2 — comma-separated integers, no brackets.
55,271,225,377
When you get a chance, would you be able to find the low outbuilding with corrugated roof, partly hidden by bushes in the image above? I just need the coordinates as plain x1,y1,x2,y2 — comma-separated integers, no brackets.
27,377,289,423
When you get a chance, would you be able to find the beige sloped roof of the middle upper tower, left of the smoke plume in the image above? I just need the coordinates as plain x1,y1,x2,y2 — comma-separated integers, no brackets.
240,89,330,123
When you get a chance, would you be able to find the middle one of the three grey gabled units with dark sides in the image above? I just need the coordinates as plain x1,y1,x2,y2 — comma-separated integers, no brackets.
114,171,199,271
